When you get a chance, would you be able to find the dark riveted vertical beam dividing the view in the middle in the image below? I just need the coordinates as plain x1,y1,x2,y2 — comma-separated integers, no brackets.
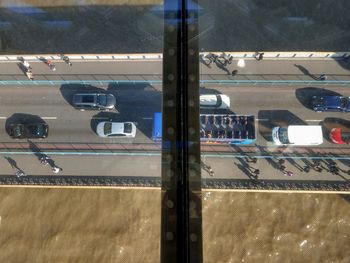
161,0,202,262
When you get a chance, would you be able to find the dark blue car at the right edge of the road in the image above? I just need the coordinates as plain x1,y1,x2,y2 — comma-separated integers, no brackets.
311,96,350,112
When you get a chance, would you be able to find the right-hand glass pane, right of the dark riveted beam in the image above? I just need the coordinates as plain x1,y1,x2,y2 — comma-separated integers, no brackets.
199,0,350,262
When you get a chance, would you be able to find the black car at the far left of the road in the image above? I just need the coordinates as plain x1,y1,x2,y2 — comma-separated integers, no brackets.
10,123,49,139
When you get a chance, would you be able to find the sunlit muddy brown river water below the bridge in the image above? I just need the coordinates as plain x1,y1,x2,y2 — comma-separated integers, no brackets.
0,188,350,263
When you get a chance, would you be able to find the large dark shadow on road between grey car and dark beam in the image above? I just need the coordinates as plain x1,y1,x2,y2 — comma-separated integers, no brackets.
107,83,162,138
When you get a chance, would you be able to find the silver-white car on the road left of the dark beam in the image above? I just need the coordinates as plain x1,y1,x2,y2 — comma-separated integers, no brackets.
96,121,136,138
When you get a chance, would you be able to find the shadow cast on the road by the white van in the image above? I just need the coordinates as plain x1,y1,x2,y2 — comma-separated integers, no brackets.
258,110,306,141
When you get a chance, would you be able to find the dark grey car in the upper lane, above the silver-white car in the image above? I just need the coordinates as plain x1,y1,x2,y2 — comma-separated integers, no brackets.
73,93,116,110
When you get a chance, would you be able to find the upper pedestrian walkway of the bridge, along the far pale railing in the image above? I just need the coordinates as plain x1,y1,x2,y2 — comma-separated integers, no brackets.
0,58,350,85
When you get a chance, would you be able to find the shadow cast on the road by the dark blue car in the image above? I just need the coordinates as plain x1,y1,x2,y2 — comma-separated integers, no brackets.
295,87,340,110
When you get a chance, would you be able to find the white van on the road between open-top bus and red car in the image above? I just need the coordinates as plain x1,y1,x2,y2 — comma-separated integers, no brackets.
272,125,323,145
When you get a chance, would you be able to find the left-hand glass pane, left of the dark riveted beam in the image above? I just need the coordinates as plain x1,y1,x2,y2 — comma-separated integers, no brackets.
0,0,163,262
